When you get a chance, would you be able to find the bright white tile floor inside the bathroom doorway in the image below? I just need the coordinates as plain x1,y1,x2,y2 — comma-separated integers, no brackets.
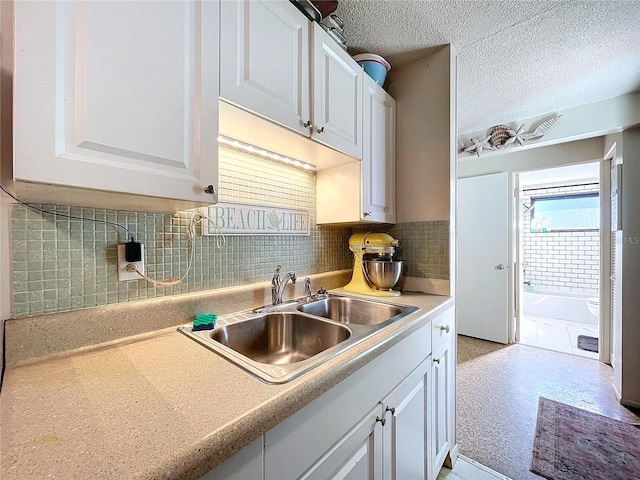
520,315,598,360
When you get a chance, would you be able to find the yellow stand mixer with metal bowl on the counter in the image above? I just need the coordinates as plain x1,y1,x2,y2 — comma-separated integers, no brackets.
344,232,402,297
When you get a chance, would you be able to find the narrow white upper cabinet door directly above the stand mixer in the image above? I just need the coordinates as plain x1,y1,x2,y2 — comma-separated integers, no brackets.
362,75,396,223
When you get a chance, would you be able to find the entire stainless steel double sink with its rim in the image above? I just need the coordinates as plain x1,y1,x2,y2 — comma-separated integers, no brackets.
178,294,418,383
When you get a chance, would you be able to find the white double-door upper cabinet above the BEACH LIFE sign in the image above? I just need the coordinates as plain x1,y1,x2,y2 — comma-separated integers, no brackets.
220,0,364,163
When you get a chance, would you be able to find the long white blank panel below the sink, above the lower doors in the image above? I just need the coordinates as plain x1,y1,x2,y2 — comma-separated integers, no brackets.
265,318,431,480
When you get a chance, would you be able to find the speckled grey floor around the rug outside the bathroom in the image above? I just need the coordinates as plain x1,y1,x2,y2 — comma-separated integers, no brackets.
452,335,640,480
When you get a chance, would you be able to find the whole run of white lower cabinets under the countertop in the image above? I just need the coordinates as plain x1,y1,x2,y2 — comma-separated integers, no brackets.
203,308,455,480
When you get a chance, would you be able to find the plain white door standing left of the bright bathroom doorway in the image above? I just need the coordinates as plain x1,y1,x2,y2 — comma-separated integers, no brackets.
457,173,511,343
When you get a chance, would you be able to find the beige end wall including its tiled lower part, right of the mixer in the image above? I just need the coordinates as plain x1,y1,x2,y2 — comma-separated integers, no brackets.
389,45,457,295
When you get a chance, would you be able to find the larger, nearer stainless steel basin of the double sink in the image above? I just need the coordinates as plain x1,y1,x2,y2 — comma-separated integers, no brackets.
211,313,351,365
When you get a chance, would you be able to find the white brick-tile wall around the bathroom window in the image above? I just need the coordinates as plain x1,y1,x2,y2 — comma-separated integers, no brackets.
523,183,600,294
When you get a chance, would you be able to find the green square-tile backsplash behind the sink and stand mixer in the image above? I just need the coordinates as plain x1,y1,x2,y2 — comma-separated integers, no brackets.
11,147,449,317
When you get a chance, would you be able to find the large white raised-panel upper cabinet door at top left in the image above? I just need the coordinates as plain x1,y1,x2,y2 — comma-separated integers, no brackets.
14,1,219,206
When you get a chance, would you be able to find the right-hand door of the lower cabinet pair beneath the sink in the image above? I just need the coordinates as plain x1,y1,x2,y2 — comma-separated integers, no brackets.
383,357,431,479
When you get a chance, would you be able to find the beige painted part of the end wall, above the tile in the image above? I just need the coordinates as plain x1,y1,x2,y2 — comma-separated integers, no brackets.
389,45,456,223
